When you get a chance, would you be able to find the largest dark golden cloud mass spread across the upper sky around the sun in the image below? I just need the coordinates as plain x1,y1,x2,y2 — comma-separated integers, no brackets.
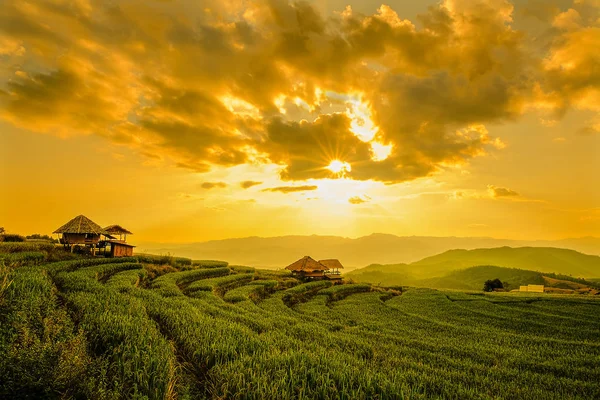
0,0,600,183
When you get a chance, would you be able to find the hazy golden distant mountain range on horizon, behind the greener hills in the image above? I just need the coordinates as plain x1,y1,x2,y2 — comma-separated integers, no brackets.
137,233,600,272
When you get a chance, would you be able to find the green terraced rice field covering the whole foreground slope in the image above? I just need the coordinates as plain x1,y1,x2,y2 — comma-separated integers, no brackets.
0,244,600,399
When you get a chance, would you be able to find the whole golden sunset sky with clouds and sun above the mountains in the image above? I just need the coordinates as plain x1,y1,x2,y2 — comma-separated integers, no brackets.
0,0,600,242
